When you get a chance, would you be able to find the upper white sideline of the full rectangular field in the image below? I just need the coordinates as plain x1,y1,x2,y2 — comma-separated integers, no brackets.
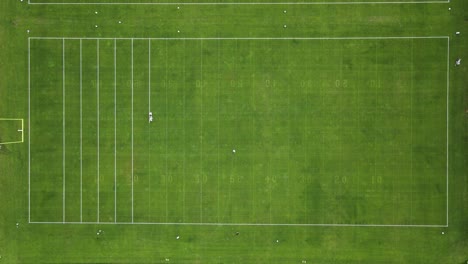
30,36,448,40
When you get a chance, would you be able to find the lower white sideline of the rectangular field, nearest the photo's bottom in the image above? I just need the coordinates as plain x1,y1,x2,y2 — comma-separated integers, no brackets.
31,222,447,228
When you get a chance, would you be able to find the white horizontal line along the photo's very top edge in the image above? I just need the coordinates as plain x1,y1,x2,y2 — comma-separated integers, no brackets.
28,0,450,5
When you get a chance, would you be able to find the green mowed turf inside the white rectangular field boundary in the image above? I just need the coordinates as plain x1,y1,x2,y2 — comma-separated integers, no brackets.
30,38,448,225
